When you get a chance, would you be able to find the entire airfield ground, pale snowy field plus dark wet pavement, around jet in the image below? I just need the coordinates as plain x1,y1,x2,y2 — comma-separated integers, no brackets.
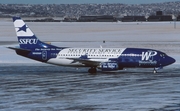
0,20,180,111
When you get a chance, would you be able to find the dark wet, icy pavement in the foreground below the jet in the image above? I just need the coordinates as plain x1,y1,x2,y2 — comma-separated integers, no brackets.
0,64,180,111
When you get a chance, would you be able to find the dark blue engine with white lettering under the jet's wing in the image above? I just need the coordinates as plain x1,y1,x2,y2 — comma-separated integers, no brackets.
98,62,119,71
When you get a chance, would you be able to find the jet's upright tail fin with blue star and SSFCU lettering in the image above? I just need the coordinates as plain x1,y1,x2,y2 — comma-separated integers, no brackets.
13,17,50,49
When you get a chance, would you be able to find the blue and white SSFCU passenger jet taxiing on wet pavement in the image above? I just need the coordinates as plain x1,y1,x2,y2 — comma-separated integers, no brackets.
8,17,175,74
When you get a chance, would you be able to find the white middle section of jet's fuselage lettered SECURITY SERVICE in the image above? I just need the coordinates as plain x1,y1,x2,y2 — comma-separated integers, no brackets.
47,48,125,67
